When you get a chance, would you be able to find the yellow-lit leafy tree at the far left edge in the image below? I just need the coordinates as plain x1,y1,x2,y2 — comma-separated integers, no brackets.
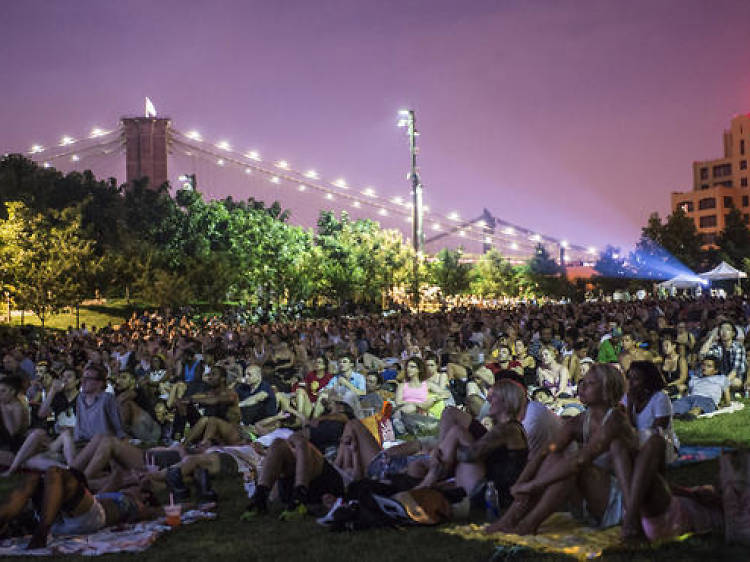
0,202,98,328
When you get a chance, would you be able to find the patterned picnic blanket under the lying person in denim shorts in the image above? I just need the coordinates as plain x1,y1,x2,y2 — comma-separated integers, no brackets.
0,509,216,556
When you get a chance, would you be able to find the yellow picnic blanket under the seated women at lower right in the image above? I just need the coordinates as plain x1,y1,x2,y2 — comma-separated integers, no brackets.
442,513,620,560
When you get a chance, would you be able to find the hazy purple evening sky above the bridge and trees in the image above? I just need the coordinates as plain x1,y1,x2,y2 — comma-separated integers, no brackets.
0,0,750,246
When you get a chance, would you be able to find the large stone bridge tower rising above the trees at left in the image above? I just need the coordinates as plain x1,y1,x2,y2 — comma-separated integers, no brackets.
121,116,171,189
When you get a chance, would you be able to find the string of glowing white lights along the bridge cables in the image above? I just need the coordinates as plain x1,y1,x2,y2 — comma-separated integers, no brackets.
22,122,597,261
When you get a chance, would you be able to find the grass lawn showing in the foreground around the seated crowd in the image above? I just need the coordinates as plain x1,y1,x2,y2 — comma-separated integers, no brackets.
0,407,750,562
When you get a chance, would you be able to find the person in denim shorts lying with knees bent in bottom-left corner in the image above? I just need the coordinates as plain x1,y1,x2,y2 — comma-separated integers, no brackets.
0,467,160,550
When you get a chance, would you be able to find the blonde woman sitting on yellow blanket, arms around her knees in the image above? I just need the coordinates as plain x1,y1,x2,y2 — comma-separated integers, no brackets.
486,364,638,535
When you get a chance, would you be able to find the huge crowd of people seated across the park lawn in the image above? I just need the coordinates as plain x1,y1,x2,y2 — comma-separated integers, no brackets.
0,296,750,547
